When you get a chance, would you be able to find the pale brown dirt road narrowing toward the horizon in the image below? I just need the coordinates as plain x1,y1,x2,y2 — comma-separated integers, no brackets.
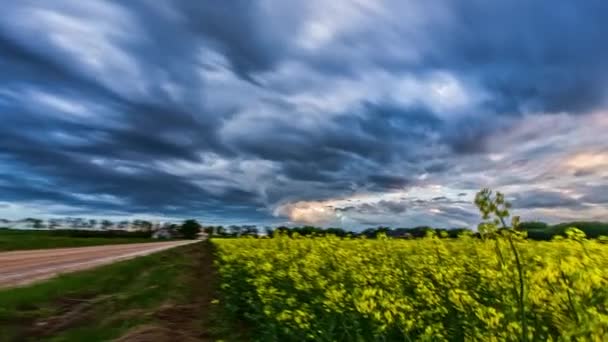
0,240,197,288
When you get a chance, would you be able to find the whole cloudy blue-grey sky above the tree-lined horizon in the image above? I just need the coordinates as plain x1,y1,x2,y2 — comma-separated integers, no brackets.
0,0,608,229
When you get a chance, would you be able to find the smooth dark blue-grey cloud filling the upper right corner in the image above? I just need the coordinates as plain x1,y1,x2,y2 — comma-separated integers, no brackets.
444,1,608,116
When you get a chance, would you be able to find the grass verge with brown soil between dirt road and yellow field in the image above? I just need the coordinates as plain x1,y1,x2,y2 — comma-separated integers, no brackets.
0,242,207,342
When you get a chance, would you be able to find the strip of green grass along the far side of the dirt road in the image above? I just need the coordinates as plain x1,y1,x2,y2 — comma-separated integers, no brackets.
0,229,157,252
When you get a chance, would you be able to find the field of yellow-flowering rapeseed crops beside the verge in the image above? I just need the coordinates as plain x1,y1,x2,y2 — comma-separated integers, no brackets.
212,234,608,341
